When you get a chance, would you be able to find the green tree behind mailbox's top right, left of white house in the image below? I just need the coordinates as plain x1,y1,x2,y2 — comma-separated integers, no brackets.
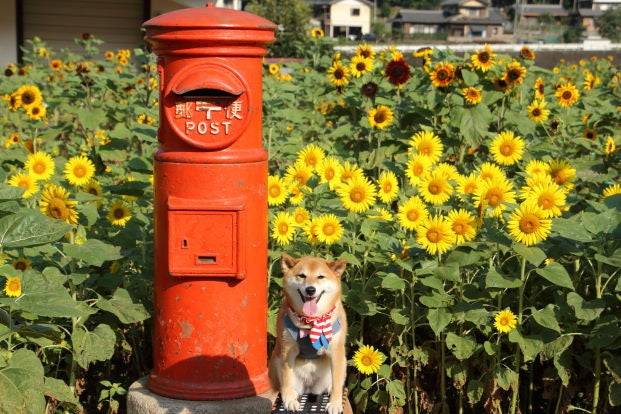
246,0,311,56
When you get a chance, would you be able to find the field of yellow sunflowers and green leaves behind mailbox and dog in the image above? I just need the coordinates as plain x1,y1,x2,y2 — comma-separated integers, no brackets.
0,33,621,414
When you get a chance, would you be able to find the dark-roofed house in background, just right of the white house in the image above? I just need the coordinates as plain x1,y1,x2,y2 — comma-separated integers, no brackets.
391,0,506,41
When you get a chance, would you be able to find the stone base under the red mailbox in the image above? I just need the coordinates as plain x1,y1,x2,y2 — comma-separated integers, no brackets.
127,378,276,414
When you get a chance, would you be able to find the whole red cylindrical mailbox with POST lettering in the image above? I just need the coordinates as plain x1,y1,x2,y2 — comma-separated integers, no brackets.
144,1,275,400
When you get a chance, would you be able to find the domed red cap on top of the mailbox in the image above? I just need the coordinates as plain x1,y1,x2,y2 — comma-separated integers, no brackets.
143,3,276,33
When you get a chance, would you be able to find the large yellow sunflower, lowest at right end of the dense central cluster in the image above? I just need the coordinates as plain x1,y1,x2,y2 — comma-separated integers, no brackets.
507,201,552,246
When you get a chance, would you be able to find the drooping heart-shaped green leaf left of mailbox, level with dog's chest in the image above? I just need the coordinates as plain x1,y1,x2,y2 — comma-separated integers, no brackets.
71,324,116,369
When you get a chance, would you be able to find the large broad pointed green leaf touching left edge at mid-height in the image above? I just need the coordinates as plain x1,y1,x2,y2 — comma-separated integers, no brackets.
0,210,71,249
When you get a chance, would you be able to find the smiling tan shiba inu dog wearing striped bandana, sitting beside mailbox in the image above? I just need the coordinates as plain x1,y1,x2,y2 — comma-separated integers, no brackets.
269,254,351,414
